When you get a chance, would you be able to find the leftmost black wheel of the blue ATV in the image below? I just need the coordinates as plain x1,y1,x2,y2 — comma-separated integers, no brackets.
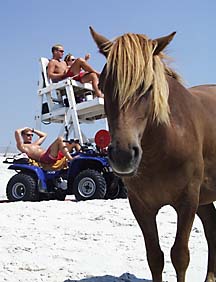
6,173,39,202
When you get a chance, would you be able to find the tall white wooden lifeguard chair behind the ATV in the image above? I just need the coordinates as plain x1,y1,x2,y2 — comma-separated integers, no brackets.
35,57,105,144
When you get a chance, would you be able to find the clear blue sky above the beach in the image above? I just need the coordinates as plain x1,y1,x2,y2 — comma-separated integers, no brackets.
0,0,216,149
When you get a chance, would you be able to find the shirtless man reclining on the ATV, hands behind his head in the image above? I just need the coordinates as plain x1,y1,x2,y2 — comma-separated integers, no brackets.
15,127,80,165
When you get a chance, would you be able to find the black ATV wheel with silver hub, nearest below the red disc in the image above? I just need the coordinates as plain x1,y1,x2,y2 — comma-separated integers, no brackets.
73,169,107,201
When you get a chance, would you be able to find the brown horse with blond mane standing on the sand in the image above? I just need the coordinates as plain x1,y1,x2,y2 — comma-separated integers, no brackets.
90,28,216,282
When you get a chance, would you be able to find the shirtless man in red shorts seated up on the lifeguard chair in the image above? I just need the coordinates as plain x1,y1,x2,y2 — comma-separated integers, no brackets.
47,44,104,97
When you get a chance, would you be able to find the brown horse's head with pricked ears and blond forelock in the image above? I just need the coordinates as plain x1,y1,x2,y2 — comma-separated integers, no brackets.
90,27,175,176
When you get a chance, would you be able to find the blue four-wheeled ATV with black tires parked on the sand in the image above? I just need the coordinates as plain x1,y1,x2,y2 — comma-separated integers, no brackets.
4,132,127,201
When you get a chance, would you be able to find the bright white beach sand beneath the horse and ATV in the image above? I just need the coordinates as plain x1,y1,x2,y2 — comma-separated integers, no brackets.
0,158,207,282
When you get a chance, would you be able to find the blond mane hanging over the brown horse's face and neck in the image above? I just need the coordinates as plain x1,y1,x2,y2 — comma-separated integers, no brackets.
103,33,181,124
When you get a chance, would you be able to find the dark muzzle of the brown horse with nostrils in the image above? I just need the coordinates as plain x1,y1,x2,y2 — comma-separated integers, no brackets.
108,144,142,176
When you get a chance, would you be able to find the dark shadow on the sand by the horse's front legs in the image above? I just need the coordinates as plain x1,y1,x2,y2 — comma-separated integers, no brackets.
64,273,152,282
